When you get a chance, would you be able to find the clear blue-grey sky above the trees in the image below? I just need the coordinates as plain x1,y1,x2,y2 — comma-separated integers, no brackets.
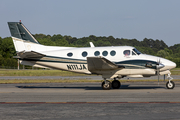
0,0,180,46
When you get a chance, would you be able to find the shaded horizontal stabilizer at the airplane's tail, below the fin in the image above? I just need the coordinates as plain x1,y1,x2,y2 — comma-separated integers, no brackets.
14,51,46,59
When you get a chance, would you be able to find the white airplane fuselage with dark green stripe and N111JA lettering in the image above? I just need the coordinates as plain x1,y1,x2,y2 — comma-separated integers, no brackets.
16,39,176,78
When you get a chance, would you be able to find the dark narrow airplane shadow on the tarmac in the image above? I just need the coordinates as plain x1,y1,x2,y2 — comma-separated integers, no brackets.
16,85,165,90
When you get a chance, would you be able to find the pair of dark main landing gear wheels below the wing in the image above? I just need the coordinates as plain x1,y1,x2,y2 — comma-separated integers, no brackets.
102,78,121,90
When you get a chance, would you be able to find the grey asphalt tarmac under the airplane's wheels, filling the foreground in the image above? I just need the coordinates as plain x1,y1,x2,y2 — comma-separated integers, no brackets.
0,82,180,120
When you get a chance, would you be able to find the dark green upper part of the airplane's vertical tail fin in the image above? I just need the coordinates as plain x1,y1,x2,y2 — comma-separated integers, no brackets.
8,22,39,44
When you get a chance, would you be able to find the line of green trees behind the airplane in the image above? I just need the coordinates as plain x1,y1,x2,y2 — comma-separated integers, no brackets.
0,34,180,68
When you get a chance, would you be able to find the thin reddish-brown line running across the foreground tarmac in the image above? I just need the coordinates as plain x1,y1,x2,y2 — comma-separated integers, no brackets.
0,102,180,104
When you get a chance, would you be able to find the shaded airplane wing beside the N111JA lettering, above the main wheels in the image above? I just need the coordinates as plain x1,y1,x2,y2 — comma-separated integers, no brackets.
87,57,124,72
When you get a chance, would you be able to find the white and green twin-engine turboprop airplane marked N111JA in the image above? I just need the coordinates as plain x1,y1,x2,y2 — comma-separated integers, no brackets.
8,22,176,90
